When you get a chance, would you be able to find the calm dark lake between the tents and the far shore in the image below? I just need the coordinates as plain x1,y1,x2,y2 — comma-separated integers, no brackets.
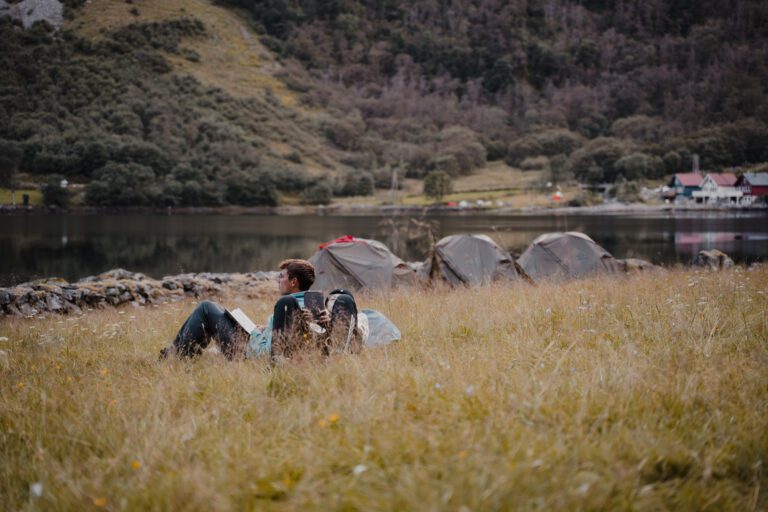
0,212,768,286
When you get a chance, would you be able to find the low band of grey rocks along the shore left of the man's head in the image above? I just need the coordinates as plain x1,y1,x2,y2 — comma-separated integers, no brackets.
0,269,277,317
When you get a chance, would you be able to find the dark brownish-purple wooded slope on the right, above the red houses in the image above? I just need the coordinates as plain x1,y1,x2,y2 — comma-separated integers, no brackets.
221,0,768,181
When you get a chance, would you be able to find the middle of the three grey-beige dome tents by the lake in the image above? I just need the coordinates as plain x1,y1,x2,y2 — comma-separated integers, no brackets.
422,235,520,286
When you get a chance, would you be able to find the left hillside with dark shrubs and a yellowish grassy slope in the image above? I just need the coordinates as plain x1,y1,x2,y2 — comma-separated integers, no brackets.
0,1,356,206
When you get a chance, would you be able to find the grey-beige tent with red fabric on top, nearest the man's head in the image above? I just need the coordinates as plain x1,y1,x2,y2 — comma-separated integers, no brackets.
309,236,415,292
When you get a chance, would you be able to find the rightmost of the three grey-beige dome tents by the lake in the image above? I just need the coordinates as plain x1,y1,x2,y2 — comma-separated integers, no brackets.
517,231,620,281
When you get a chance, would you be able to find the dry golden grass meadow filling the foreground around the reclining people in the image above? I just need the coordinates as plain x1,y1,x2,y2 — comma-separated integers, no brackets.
0,266,768,510
